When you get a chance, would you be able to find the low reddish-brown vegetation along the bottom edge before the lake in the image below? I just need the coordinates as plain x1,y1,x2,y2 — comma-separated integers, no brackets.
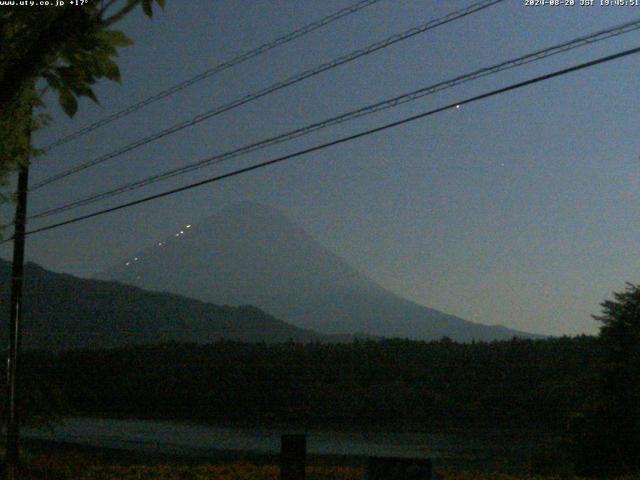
7,441,638,480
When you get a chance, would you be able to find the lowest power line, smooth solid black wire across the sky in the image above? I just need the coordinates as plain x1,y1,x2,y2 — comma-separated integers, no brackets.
10,43,640,243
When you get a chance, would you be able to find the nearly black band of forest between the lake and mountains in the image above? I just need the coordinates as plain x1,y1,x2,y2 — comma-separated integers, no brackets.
25,336,602,431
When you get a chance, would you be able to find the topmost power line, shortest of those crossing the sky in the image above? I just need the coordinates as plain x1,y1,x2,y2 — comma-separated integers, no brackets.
43,0,380,152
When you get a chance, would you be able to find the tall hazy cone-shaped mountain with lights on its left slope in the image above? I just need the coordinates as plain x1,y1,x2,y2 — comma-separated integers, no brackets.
98,202,532,341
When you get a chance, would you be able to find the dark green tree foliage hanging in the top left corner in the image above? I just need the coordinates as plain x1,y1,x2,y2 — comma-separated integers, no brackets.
0,0,165,178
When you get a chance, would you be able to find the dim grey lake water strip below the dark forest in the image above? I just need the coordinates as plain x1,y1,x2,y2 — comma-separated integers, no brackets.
22,418,544,465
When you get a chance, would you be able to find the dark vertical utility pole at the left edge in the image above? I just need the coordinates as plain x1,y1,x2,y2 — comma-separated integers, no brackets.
5,128,31,480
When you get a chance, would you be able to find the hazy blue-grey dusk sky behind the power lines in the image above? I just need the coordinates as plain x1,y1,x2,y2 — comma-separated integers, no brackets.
0,0,640,334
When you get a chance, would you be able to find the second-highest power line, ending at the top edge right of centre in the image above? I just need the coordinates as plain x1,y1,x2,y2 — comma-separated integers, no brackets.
30,0,504,191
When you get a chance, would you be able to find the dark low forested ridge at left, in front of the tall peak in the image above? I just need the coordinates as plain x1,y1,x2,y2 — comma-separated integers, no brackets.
0,260,340,350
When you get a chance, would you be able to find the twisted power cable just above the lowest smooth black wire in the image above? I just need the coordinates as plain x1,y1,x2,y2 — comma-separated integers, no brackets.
28,19,640,220
